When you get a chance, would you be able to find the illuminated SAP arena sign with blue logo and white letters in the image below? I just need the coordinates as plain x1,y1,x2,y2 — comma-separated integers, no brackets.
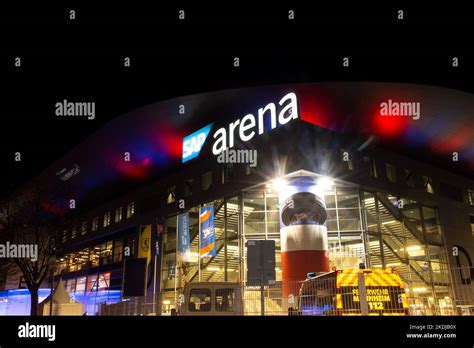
182,92,299,163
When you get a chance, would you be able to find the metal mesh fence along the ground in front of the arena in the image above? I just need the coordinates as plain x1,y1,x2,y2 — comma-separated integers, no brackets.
99,267,474,316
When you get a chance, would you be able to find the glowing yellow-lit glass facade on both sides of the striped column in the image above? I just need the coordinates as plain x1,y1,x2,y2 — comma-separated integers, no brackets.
161,171,453,315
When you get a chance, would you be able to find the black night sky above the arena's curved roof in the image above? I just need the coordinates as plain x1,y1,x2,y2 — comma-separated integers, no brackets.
0,2,474,197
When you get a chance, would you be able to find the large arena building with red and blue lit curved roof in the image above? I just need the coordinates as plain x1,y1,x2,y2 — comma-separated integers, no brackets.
0,82,474,315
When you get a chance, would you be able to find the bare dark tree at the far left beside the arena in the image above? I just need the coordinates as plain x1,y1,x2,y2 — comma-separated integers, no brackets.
0,184,60,315
